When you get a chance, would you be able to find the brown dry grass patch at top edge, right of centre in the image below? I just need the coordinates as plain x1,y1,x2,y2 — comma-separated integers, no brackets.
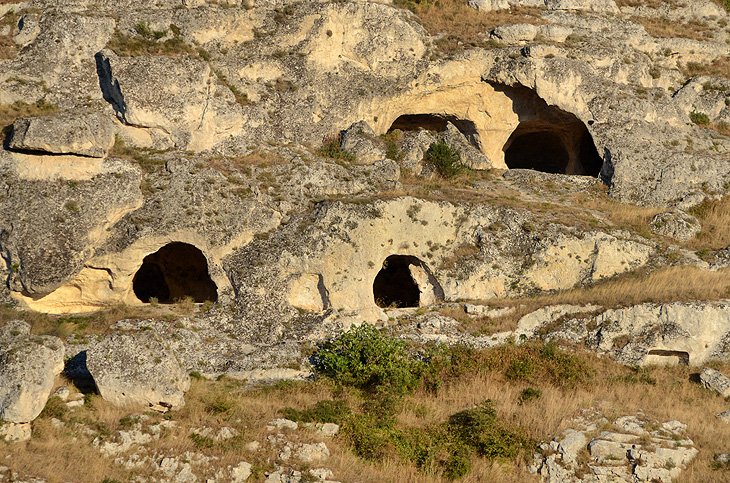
395,0,546,53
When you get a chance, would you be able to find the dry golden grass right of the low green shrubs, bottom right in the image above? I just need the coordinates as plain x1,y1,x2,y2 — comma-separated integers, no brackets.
403,360,730,483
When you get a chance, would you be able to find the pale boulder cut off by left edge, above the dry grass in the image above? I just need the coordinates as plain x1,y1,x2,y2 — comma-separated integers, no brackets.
0,331,65,423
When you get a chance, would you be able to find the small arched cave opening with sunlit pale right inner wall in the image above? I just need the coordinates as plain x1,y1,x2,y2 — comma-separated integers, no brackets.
373,255,444,308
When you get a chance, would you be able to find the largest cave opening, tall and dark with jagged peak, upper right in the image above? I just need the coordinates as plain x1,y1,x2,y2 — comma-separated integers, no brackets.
495,86,603,176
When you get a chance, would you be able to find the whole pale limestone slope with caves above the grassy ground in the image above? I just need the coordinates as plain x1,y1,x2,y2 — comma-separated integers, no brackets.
0,0,730,481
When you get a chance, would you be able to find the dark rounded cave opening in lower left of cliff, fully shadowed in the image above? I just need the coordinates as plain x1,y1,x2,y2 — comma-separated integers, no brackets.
132,242,218,304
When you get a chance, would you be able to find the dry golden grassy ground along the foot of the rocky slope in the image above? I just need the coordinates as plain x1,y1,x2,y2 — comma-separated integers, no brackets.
0,338,730,483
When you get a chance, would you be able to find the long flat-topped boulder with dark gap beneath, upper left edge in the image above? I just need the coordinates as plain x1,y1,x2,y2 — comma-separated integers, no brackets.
8,114,114,158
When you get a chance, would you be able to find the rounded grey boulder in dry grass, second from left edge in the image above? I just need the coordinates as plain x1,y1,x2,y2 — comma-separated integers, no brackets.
86,331,190,409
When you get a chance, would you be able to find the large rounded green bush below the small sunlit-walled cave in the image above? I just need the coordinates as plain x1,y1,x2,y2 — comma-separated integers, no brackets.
314,324,425,396
